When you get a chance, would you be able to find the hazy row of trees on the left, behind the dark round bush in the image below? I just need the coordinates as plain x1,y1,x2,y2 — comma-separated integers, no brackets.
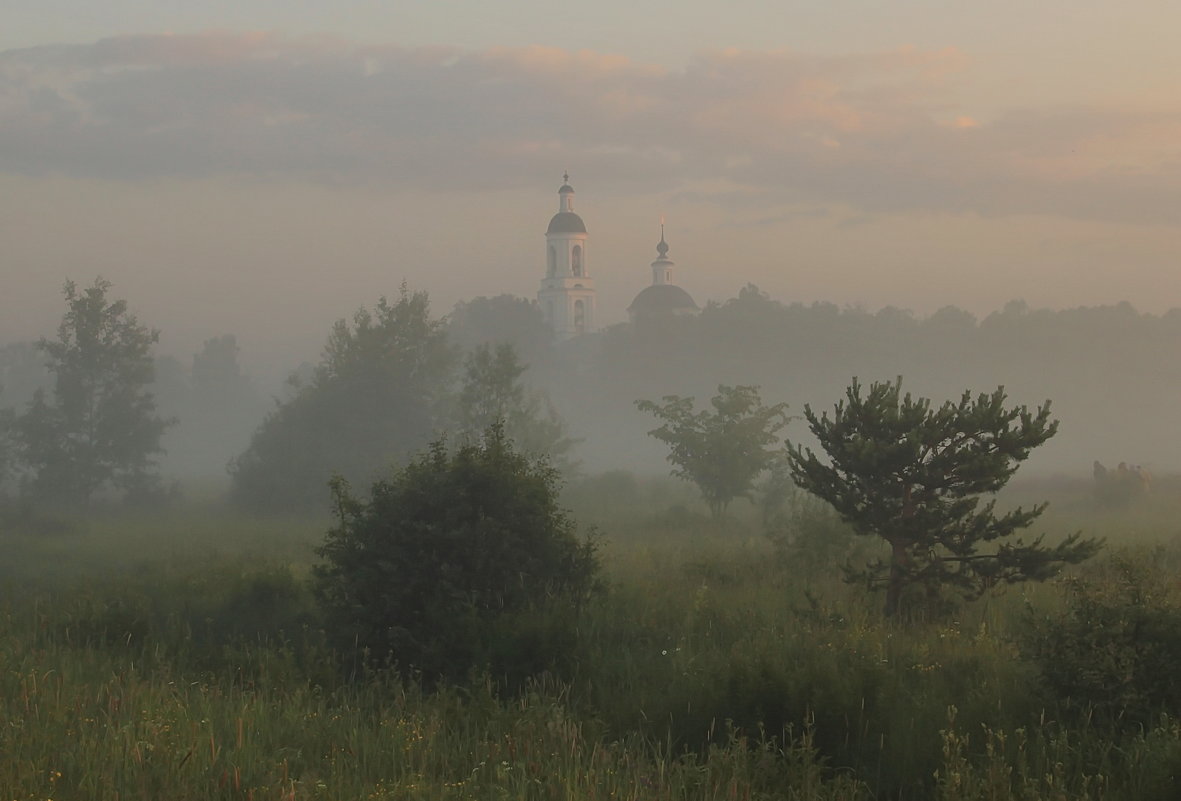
0,279,574,513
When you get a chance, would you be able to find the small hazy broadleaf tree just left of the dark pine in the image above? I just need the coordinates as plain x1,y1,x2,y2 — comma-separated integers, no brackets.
635,384,788,517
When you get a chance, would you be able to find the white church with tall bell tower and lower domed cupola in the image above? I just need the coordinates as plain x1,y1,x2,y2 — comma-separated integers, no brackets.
537,174,698,340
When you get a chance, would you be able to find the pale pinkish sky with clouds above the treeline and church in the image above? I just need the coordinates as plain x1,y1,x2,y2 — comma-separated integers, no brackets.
0,0,1181,366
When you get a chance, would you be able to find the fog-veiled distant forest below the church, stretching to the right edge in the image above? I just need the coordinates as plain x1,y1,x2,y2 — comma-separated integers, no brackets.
539,286,1181,477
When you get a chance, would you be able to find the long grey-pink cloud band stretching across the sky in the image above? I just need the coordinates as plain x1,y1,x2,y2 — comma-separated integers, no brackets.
0,33,1181,221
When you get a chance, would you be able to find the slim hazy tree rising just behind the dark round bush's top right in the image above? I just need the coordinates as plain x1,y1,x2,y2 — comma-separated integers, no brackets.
456,344,575,467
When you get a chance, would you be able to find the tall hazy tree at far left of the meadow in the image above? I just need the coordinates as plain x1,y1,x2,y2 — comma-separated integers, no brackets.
17,278,171,504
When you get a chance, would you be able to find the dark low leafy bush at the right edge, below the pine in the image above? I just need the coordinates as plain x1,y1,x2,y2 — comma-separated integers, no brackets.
1025,548,1181,728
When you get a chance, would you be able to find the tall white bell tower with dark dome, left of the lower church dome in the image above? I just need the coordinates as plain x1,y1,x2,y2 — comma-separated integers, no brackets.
537,174,599,340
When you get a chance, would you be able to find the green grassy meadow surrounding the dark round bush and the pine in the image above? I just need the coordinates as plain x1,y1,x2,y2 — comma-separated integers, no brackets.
0,474,1181,801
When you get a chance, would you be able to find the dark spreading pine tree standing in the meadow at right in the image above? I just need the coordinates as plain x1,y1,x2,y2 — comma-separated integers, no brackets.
789,378,1100,616
